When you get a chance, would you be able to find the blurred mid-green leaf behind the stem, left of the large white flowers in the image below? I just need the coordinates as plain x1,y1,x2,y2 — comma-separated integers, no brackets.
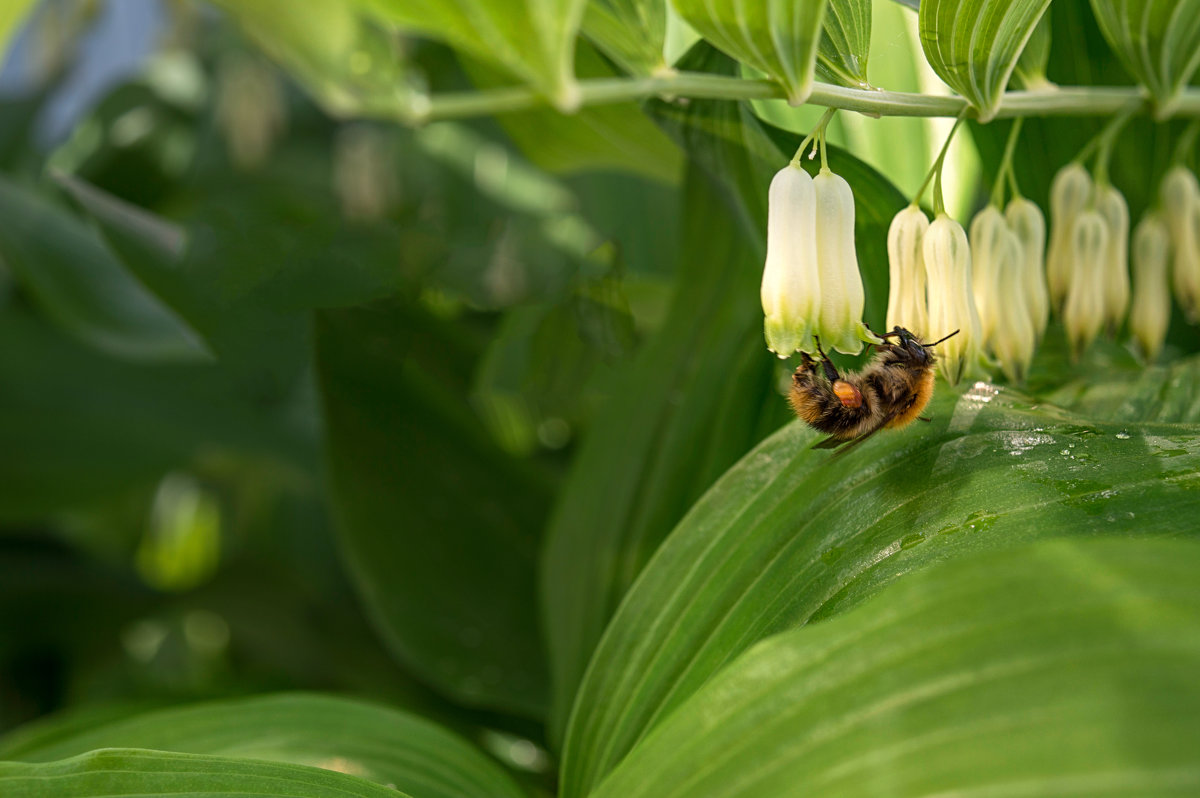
464,42,682,184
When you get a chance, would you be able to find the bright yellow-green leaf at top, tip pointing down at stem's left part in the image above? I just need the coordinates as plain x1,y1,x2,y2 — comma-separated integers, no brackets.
367,0,586,112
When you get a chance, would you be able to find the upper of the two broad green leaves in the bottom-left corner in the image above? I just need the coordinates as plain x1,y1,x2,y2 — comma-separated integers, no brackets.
0,694,524,798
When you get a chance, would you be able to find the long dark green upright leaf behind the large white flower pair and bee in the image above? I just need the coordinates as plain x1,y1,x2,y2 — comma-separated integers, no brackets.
542,44,905,738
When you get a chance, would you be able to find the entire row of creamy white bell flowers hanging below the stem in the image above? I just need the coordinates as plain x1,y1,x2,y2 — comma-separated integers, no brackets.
762,146,1200,384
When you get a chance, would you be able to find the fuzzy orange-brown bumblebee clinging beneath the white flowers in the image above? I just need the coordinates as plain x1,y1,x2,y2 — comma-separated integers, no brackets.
788,326,958,451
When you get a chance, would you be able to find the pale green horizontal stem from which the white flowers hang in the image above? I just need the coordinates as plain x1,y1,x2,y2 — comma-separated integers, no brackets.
408,72,1200,121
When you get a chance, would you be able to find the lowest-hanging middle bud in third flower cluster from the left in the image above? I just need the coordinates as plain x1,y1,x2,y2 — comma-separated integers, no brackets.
972,228,1037,383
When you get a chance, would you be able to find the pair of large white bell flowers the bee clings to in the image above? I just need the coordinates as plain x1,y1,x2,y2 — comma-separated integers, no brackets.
762,163,877,358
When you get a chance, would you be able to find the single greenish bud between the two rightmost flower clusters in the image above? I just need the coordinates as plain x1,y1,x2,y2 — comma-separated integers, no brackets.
1129,212,1171,360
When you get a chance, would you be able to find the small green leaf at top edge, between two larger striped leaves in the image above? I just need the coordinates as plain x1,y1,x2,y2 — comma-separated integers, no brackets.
583,0,667,76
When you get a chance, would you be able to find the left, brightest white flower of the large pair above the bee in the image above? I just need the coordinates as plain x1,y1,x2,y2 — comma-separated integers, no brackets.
761,164,820,358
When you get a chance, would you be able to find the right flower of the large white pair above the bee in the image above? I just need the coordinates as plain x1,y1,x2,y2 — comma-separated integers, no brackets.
812,168,877,355
